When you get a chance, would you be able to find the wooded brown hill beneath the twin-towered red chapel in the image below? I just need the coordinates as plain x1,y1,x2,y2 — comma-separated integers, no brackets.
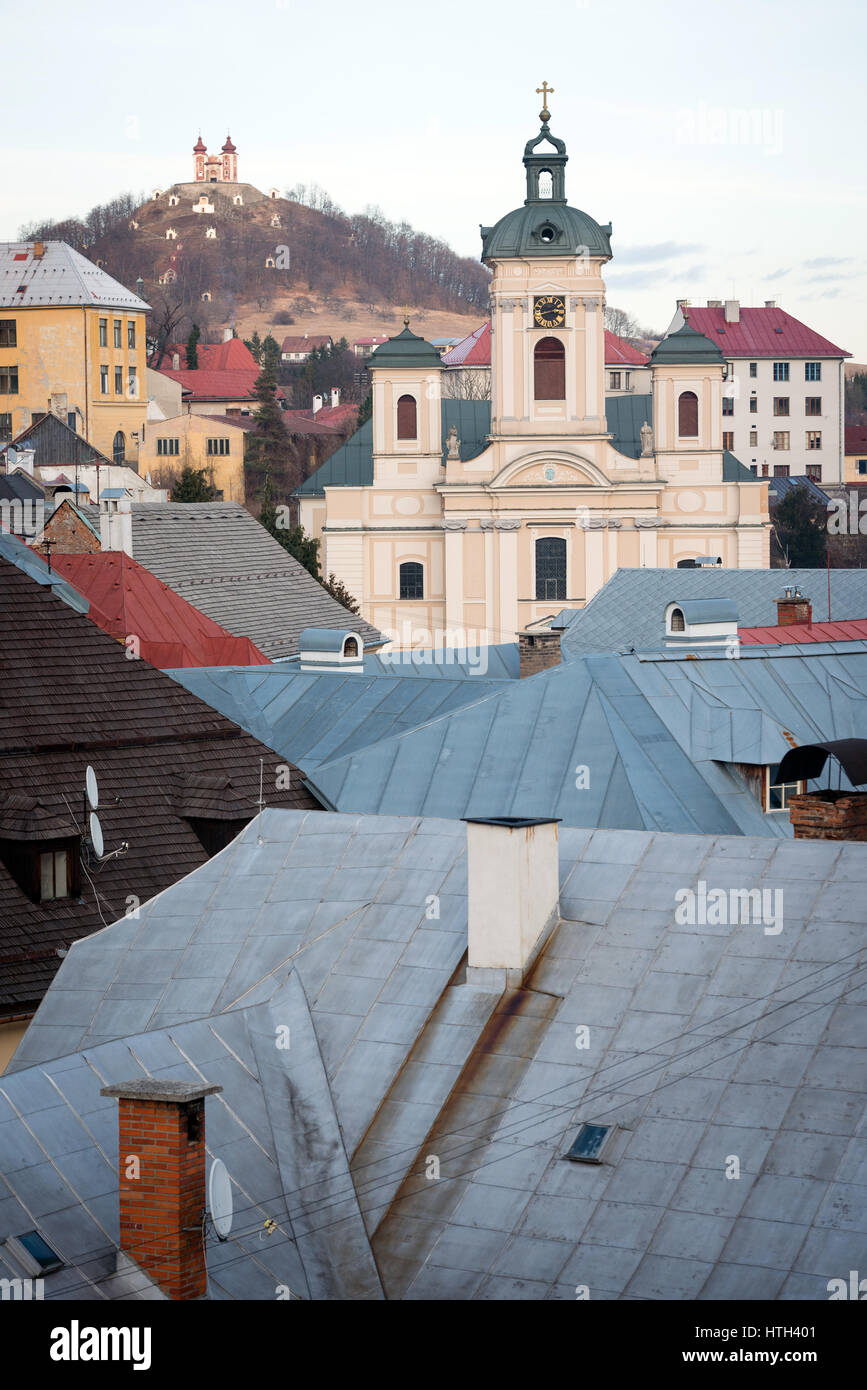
22,183,489,353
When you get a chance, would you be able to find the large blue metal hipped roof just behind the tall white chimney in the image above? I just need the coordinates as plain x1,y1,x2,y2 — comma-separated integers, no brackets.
302,642,867,837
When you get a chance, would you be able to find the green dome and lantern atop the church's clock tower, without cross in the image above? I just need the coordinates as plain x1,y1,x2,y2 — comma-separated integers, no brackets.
481,119,611,261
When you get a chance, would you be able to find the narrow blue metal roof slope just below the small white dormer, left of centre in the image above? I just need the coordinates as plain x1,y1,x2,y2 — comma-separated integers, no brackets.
168,659,503,771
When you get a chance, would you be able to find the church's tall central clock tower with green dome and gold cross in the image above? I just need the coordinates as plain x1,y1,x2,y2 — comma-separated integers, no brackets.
481,86,611,439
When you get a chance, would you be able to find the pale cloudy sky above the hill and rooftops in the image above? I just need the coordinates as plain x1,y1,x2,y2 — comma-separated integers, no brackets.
6,0,867,363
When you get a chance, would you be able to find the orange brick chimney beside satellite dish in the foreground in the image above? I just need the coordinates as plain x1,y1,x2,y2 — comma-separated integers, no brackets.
100,1077,222,1300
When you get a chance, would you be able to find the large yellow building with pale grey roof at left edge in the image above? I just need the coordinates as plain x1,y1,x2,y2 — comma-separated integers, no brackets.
0,242,149,466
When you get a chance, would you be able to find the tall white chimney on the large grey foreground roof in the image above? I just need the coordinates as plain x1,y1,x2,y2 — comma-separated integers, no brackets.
467,816,559,988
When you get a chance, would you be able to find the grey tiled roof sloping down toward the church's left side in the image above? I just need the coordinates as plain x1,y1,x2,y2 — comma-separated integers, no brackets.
109,502,383,659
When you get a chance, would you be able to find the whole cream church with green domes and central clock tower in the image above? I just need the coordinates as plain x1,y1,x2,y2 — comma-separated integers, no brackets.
295,89,770,646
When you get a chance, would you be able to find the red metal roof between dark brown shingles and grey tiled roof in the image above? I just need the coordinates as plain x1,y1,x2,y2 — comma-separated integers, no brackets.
51,550,271,670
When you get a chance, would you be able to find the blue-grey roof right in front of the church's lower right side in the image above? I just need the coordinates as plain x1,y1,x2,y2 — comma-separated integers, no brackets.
559,567,867,657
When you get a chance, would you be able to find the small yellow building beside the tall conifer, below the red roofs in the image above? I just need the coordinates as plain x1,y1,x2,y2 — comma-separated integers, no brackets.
139,410,247,502
